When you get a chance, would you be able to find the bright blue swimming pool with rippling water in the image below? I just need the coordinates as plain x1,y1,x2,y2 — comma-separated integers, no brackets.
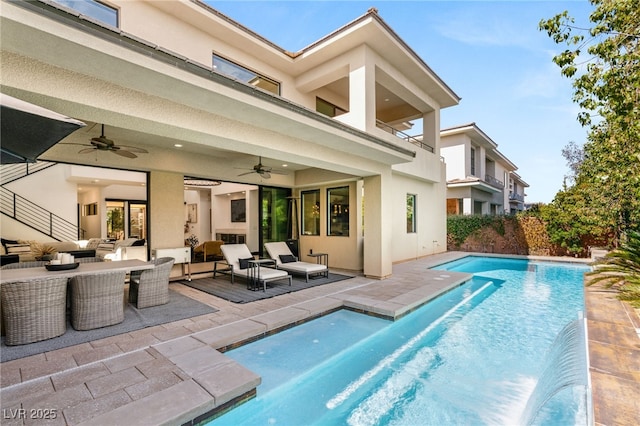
210,257,588,426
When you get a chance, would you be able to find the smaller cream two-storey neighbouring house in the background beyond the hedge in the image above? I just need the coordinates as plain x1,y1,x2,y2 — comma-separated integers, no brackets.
440,123,529,215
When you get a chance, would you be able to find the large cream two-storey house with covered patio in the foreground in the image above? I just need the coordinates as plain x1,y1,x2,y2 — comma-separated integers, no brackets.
0,0,460,278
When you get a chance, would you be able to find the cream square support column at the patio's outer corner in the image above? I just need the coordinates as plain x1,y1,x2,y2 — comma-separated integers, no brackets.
364,169,393,279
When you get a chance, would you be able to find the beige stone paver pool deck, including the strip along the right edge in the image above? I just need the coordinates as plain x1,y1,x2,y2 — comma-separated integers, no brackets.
0,252,640,425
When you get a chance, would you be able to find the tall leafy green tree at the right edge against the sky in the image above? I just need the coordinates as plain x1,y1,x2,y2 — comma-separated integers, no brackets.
539,0,640,245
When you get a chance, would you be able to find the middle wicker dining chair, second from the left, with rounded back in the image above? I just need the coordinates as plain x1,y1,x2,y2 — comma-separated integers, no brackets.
70,271,126,330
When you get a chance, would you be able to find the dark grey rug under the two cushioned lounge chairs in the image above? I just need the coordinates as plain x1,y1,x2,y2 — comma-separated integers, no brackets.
179,273,353,303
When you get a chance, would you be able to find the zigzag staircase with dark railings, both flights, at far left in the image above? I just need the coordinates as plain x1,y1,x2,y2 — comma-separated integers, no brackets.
0,161,81,241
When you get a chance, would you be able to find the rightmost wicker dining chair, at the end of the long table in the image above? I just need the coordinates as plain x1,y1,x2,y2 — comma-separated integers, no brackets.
129,257,175,309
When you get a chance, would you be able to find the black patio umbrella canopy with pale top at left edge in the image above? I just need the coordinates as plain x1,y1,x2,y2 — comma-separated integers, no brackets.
0,94,86,164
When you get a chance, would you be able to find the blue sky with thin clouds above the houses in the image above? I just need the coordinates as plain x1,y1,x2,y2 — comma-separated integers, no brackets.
207,0,593,203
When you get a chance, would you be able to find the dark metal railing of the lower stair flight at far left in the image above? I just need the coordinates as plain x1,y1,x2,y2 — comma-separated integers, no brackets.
0,187,80,241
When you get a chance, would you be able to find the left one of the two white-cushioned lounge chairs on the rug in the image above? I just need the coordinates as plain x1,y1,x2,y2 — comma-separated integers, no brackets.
220,244,291,291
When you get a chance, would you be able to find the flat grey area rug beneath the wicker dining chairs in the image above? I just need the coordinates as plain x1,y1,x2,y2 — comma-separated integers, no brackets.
0,289,218,362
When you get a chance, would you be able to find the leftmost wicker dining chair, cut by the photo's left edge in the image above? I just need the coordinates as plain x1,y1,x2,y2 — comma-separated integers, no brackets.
1,277,67,345
